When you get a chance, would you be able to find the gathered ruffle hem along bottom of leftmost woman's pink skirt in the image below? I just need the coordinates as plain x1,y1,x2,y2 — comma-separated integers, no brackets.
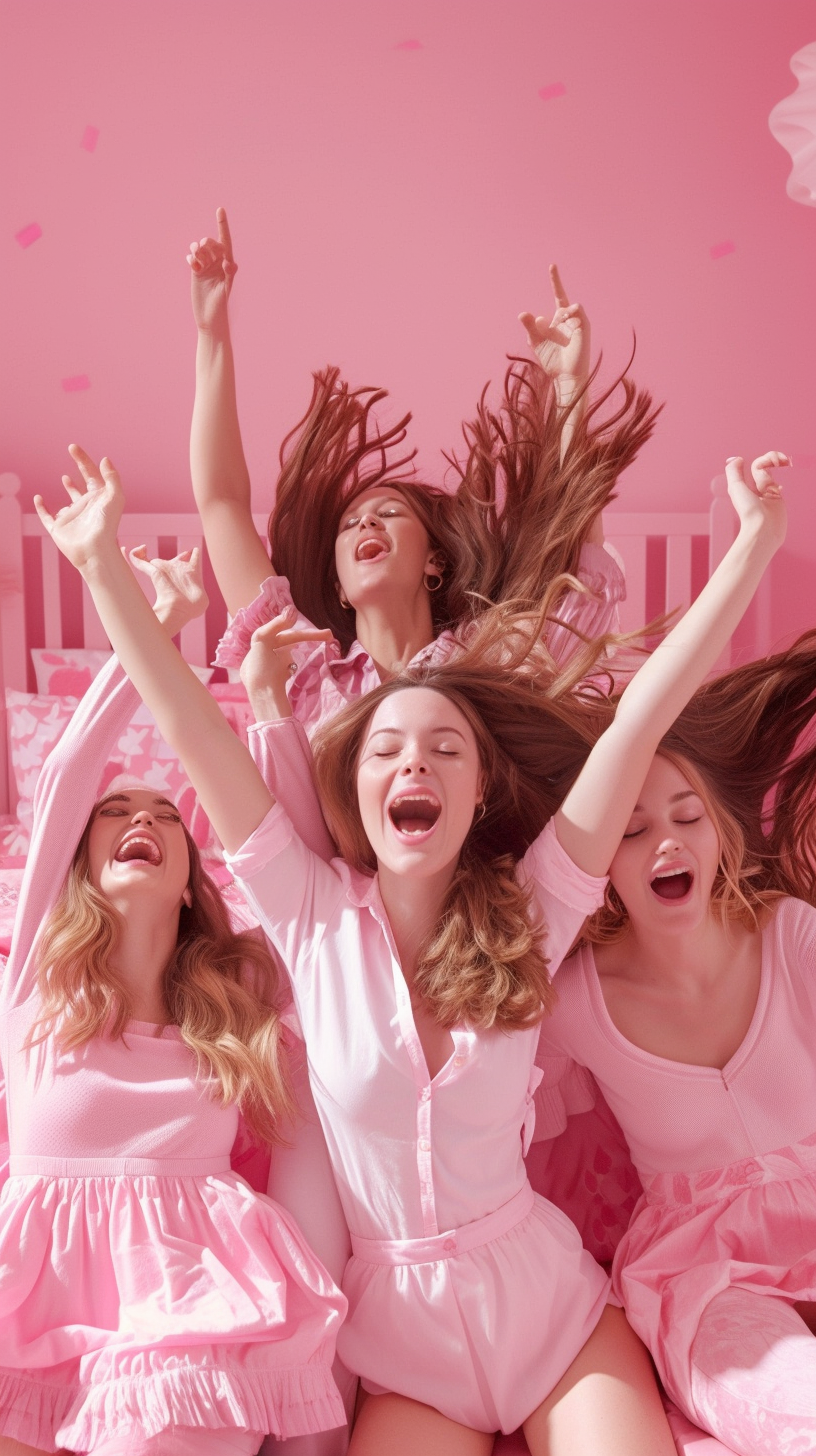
0,1363,345,1450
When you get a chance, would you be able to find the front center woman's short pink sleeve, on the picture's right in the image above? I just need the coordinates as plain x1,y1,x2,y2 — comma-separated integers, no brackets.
519,820,606,976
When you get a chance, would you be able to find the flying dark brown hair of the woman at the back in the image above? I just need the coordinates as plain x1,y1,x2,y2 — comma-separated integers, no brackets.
270,360,659,652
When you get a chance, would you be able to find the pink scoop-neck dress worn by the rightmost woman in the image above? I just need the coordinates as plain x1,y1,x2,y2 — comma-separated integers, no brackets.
536,900,816,1456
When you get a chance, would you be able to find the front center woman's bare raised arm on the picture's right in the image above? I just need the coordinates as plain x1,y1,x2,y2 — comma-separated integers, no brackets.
555,450,790,875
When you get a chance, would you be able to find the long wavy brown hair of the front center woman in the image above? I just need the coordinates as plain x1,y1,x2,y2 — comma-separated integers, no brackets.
313,596,611,1029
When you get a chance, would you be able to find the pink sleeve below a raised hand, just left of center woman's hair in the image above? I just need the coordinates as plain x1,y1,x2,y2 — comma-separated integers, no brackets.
248,718,337,863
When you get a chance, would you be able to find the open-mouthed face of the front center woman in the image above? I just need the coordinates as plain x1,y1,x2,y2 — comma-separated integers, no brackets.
357,687,482,878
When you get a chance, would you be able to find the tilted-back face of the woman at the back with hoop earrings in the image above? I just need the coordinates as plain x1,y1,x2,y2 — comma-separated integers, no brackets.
334,485,439,607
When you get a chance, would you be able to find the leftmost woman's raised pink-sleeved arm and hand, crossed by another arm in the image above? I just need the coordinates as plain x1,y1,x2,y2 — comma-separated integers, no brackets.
4,552,207,999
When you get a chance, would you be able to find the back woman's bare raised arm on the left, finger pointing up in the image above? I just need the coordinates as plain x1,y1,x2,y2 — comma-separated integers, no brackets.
187,207,270,616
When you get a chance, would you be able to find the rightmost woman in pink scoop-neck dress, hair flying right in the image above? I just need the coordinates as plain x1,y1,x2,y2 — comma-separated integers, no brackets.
539,632,816,1456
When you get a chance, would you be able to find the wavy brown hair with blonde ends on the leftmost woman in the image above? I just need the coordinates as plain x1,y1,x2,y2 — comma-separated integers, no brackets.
31,808,294,1142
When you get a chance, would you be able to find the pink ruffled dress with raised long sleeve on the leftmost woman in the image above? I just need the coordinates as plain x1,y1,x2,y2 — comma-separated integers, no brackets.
0,662,345,1452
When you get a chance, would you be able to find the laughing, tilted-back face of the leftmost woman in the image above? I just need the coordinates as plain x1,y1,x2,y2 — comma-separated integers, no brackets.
87,788,189,906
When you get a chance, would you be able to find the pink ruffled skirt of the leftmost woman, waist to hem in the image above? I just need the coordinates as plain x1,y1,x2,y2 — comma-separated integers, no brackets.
0,1158,345,1450
